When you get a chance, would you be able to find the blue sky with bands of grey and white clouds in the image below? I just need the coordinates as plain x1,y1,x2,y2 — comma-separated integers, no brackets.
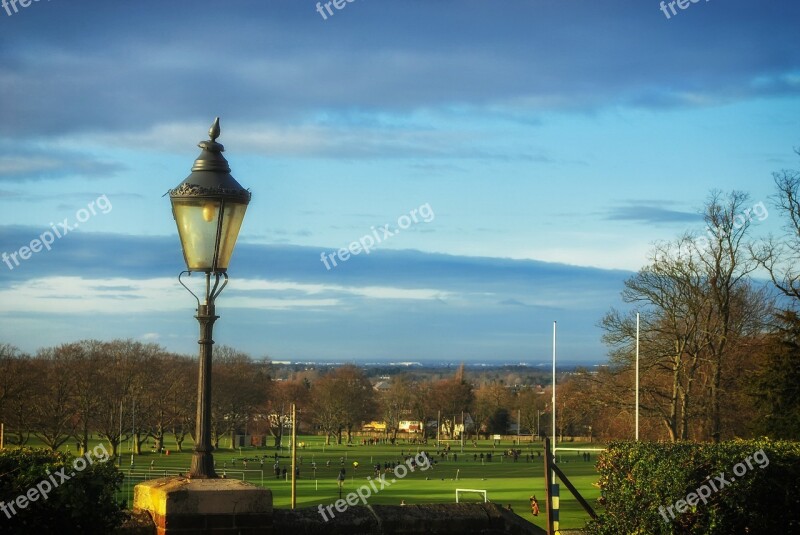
0,0,800,363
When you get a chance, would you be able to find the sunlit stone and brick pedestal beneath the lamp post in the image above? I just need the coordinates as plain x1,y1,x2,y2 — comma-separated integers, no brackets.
133,477,272,535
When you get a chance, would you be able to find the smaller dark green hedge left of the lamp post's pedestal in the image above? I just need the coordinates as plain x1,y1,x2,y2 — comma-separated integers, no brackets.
0,448,123,535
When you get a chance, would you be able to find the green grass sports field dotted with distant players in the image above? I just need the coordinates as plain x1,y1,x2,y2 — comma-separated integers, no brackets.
15,436,599,529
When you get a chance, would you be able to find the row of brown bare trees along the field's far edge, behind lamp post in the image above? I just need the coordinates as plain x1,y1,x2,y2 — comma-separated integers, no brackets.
0,340,544,455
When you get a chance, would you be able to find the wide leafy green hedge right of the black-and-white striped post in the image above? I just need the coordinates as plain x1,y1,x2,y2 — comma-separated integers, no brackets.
586,439,800,535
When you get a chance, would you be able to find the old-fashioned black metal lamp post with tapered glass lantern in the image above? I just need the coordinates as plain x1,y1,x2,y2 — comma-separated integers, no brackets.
169,117,250,479
